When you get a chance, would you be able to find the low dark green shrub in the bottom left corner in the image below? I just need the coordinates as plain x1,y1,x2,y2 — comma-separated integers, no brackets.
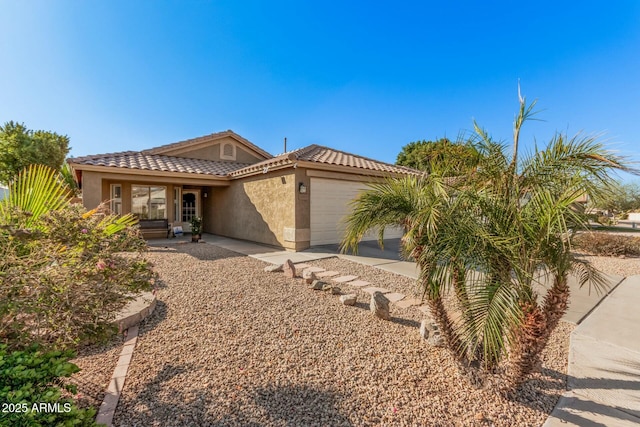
0,345,97,427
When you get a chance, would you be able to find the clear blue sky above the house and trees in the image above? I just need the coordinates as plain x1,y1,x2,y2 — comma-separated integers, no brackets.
0,0,640,178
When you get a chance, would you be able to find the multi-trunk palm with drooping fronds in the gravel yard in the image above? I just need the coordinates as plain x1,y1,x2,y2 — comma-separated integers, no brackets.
342,94,631,390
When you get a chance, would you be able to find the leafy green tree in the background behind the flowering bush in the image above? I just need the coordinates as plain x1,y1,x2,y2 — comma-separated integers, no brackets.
0,121,69,184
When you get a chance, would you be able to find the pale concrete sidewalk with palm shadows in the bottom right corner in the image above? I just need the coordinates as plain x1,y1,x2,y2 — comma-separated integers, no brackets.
544,276,640,427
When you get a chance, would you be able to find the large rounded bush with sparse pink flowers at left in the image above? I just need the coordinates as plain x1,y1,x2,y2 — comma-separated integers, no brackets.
0,166,154,349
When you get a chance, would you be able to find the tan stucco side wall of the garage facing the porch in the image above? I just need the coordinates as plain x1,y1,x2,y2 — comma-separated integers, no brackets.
211,169,297,250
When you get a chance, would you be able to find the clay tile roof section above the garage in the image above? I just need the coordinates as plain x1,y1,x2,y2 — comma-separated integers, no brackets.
230,144,420,177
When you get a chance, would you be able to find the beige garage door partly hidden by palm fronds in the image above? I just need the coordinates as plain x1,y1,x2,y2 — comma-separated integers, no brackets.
310,178,402,245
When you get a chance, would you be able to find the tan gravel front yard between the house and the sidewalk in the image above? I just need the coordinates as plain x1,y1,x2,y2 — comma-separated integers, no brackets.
95,244,571,426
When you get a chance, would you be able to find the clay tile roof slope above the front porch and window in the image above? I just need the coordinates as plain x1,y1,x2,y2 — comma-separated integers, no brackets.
69,151,249,177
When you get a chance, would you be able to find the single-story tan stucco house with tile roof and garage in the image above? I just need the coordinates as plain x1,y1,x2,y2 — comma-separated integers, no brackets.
68,130,417,251
